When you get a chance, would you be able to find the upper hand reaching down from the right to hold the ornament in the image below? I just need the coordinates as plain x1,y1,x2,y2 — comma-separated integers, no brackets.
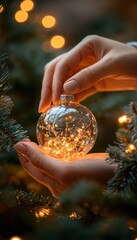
39,35,137,112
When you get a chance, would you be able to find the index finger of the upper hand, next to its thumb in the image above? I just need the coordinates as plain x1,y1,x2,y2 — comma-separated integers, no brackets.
52,37,95,103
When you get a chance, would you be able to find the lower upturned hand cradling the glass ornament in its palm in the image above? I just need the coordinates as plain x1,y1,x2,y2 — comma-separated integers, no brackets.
14,140,114,197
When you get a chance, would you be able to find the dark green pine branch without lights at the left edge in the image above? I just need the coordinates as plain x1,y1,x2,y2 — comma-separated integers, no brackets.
0,54,26,151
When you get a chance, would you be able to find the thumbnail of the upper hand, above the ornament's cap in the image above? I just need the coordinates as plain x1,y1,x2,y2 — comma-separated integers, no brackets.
64,79,80,93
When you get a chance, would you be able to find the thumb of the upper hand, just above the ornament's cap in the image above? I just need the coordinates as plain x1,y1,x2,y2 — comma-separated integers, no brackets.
63,55,114,94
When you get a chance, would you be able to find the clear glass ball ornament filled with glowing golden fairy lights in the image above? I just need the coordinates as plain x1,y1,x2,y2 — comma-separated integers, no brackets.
36,94,97,161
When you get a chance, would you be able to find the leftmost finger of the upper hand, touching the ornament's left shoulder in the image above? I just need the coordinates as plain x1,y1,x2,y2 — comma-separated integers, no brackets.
38,54,64,112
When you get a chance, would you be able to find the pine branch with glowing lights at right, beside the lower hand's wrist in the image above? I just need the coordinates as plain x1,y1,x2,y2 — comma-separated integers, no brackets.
107,103,137,194
